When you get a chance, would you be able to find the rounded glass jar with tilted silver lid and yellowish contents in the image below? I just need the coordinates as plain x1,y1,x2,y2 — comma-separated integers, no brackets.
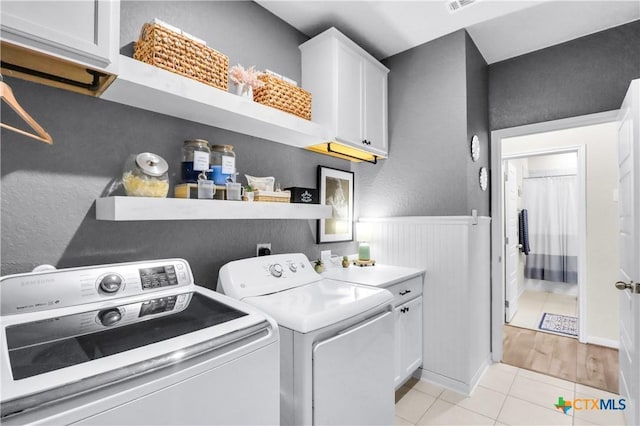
122,152,169,198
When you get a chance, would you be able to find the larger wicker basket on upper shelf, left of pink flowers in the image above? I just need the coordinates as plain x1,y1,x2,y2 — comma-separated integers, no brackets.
133,23,229,91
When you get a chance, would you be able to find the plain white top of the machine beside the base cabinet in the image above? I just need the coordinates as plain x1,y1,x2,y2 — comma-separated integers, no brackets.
243,279,393,333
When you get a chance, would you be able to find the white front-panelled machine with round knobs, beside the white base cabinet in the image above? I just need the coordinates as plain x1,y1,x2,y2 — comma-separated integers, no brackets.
217,253,395,425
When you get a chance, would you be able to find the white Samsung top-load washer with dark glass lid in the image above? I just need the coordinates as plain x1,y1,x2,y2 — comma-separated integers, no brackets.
0,259,280,425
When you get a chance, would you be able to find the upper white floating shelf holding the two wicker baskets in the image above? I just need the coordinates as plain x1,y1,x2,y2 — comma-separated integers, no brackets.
101,55,331,148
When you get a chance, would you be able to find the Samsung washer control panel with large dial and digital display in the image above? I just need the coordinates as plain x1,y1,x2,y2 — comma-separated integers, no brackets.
0,259,193,314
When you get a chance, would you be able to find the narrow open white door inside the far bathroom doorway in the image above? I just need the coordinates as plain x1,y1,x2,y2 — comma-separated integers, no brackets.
504,161,518,322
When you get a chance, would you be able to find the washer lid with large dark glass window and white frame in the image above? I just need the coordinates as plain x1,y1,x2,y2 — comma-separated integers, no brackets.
0,285,278,423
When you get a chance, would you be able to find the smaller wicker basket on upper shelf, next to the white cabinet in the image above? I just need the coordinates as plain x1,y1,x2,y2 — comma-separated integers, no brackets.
253,74,311,120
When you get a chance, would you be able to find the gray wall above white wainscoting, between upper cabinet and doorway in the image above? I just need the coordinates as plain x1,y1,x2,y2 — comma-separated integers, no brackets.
355,30,489,217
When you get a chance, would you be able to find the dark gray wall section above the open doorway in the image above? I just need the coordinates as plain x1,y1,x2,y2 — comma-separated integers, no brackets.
489,21,640,130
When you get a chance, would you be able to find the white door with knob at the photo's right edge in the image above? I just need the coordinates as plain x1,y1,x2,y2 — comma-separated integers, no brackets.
616,80,640,425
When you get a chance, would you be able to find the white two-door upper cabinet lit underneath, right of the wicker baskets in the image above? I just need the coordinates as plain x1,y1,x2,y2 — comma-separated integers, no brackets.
300,28,389,157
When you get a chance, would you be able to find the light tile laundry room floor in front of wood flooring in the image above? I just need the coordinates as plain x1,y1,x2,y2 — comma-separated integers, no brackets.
396,363,625,425
